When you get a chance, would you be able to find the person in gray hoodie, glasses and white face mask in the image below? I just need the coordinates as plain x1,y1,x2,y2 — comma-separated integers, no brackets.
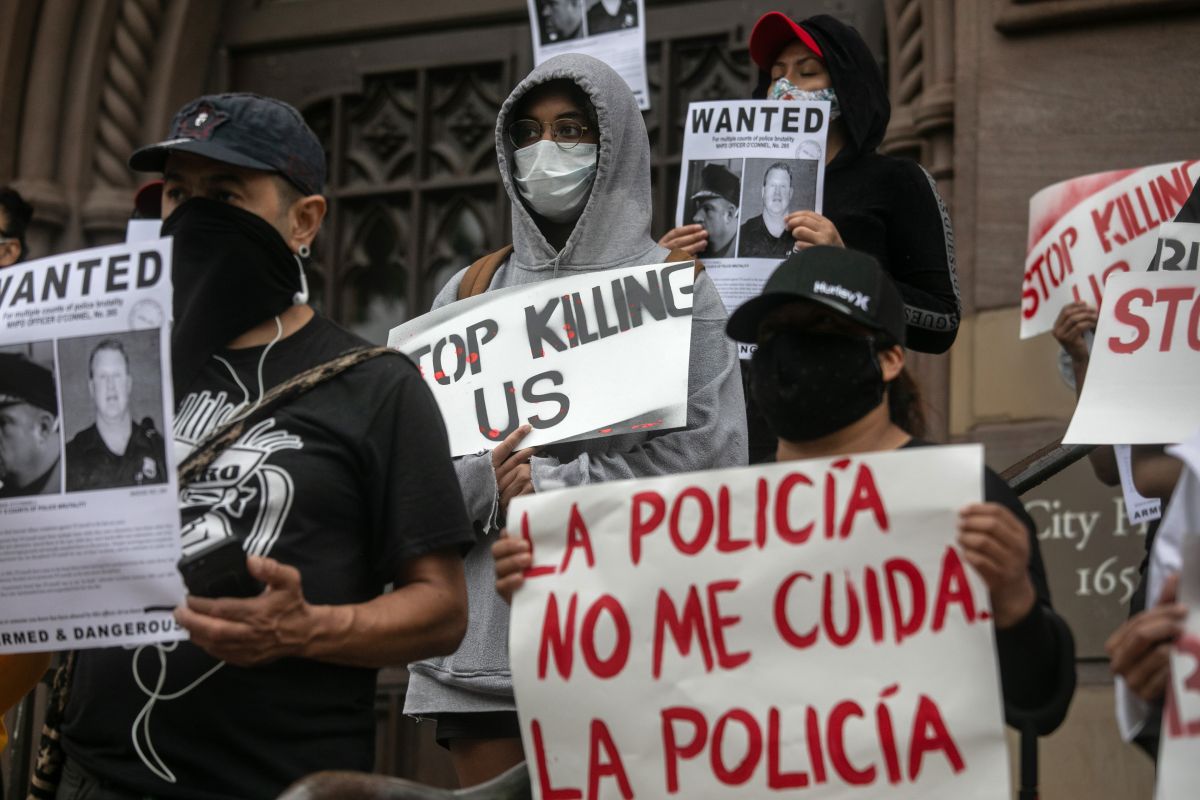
404,54,746,786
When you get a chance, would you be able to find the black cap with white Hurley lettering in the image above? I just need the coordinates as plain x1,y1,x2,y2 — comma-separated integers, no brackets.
725,245,905,344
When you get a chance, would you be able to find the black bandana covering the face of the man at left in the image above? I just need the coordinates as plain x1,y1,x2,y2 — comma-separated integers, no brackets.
162,198,300,403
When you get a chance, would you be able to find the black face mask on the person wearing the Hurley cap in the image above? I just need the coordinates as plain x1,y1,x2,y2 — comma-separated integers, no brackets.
750,331,883,441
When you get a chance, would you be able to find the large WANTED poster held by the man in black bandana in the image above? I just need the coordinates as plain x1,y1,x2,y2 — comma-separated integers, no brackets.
0,239,184,652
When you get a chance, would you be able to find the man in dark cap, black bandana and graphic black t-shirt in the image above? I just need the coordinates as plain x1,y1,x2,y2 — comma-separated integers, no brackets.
60,94,475,799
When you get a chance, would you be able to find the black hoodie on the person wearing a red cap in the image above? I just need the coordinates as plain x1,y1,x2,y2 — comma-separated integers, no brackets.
755,14,960,353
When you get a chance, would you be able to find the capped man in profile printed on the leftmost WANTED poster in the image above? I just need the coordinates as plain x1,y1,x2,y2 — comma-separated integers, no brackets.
0,353,62,499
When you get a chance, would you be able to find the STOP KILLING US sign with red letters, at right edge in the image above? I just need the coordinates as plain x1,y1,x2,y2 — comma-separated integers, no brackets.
1021,161,1200,339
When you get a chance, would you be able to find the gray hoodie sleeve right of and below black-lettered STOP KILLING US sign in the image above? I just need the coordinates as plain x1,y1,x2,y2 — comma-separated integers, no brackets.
530,272,748,491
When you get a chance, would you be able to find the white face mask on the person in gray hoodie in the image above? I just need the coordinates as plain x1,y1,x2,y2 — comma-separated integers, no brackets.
512,139,599,222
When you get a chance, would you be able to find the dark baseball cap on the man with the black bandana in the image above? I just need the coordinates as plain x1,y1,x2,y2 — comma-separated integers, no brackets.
130,94,325,194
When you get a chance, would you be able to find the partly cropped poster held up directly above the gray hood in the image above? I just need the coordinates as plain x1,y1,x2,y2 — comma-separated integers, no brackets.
527,0,650,112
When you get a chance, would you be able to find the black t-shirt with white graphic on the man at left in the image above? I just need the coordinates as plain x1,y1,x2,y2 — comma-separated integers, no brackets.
64,317,474,800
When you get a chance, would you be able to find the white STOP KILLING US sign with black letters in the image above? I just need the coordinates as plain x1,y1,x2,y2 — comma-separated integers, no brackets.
388,261,695,456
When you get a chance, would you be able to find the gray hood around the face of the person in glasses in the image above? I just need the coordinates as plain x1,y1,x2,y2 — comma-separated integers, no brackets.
496,54,658,270
